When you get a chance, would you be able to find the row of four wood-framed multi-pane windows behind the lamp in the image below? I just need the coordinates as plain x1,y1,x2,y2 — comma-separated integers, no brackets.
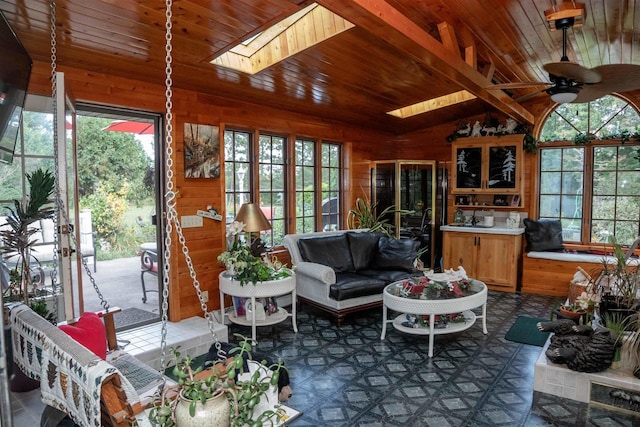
224,129,342,246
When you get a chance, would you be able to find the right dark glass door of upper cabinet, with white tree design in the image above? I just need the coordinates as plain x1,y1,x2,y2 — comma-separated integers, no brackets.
484,143,522,193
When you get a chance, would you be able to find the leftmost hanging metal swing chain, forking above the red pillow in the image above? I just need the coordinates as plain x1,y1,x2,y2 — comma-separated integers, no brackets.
50,1,109,317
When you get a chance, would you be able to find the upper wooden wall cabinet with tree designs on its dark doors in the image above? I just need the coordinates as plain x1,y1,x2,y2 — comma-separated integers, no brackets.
451,135,524,207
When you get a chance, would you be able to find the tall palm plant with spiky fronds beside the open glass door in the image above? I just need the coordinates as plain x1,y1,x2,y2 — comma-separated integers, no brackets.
0,168,55,304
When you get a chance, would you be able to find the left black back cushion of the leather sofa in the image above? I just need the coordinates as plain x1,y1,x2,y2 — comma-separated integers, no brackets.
298,234,355,273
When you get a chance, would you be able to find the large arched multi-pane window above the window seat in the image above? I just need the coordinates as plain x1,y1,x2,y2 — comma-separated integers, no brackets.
538,95,640,245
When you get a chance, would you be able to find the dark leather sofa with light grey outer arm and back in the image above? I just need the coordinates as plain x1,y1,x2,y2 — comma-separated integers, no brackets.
284,230,422,325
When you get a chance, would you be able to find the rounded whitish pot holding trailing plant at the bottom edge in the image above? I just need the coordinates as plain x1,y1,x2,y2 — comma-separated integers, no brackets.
175,392,230,427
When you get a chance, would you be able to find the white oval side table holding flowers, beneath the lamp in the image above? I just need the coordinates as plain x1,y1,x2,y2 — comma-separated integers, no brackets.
218,271,298,340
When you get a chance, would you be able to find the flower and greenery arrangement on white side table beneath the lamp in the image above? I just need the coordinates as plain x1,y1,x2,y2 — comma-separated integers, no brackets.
218,221,292,286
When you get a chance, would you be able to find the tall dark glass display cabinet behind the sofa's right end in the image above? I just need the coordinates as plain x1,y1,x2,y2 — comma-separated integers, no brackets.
371,160,437,268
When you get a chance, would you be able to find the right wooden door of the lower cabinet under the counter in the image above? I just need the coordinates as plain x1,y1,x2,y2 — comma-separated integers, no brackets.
475,234,520,290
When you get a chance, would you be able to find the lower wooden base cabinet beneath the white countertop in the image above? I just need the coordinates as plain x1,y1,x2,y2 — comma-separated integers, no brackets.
443,231,522,292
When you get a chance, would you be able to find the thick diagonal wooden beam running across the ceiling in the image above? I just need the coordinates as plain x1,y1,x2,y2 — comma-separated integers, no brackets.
317,0,534,124
